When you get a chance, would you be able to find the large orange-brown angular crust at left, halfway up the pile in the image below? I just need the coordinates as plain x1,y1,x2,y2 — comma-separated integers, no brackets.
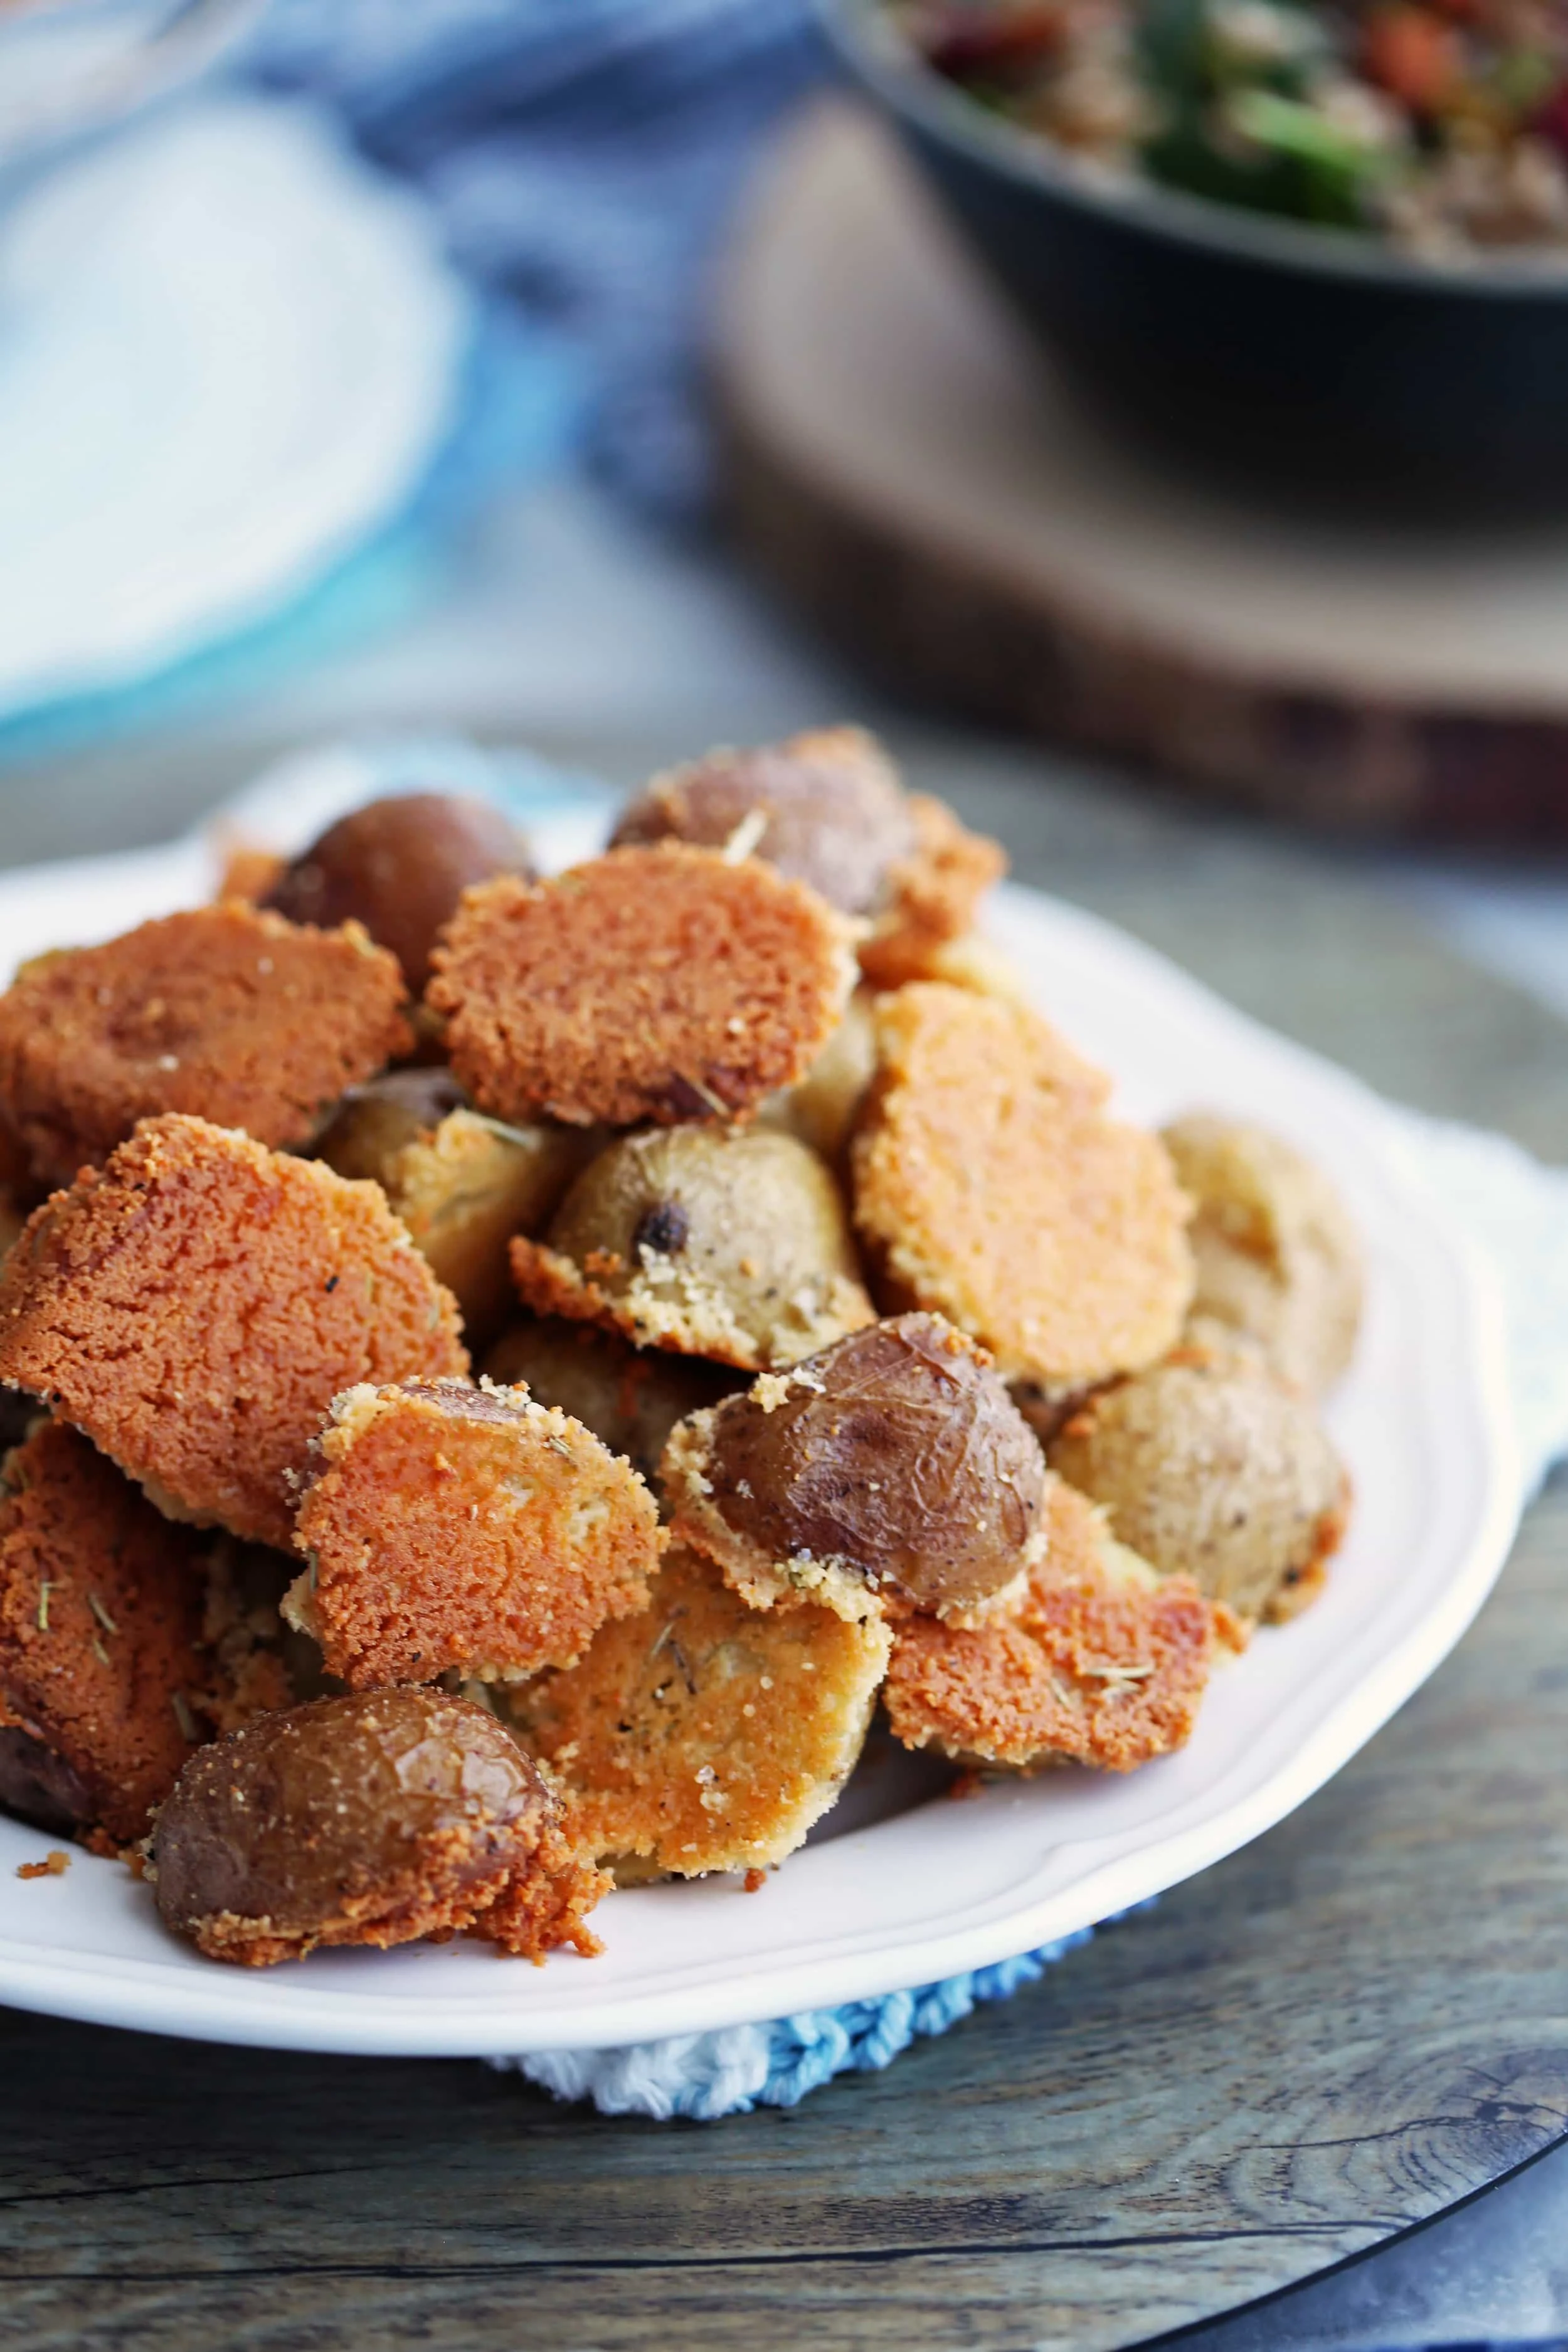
0,1117,468,1550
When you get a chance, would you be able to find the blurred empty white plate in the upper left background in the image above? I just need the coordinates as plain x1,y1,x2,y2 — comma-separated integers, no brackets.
0,96,472,720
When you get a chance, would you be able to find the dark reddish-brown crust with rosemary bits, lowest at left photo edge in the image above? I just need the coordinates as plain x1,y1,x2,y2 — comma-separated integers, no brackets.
0,1421,211,1844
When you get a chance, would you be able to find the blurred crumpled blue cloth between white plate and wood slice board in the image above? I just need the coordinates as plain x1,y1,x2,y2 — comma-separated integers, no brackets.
252,0,827,517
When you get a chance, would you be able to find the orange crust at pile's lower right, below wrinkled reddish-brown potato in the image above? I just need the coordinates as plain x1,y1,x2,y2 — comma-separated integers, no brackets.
884,1480,1234,1771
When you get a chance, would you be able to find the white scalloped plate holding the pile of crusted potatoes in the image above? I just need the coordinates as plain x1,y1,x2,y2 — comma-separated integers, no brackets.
0,824,1518,2056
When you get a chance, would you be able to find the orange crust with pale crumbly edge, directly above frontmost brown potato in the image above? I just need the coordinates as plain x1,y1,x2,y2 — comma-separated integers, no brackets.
287,1380,660,1691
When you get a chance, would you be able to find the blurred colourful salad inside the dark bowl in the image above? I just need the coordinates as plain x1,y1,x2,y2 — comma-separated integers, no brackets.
889,0,1568,259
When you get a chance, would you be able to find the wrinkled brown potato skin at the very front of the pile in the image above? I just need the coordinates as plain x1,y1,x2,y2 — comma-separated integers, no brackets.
153,1689,559,1966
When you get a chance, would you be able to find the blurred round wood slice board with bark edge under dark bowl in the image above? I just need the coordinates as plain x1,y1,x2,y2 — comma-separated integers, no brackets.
714,99,1568,840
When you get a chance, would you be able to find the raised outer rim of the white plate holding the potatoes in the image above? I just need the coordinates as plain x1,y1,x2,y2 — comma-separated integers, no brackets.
0,856,1523,2058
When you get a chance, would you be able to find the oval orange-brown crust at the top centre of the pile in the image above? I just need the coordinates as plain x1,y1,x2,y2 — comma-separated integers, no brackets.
428,842,851,1126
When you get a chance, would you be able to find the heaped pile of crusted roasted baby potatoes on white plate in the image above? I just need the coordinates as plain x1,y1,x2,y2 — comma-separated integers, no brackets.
0,729,1359,1966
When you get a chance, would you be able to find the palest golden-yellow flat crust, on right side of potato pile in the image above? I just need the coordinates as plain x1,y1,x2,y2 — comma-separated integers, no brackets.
854,981,1192,1390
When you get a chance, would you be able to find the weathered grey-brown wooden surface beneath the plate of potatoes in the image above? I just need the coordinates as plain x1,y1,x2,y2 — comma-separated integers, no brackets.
0,736,1568,2352
